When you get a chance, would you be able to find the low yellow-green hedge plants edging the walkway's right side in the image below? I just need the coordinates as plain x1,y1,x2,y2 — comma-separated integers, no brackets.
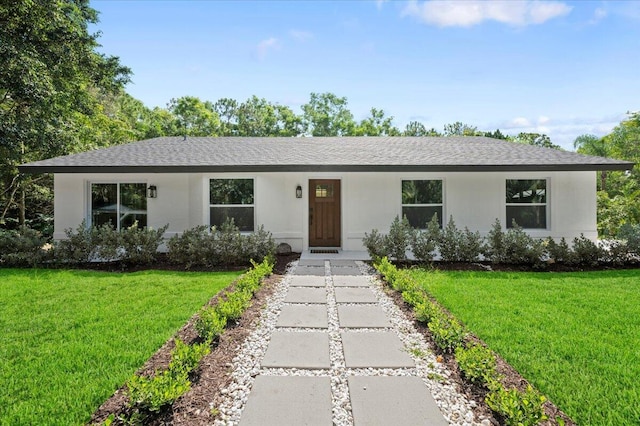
374,257,547,426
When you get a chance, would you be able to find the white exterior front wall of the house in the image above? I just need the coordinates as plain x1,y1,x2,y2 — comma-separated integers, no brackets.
54,172,597,251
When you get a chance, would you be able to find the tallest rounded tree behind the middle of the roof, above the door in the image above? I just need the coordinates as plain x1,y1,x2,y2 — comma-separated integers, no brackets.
302,93,355,136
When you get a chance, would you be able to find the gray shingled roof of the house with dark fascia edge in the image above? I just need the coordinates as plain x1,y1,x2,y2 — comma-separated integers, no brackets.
19,137,633,173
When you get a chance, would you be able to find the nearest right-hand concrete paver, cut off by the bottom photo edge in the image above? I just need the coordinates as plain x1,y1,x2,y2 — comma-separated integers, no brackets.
348,376,449,426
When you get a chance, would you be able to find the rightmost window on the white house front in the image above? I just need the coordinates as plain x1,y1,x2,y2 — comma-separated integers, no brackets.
506,179,547,229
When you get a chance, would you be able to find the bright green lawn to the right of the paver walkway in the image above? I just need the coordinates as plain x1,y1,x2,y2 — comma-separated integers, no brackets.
412,270,640,425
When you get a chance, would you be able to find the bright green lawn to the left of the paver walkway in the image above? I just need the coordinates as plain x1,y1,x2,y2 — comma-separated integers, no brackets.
0,269,239,425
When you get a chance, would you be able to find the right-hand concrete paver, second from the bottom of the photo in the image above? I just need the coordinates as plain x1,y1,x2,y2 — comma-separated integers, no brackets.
341,331,415,368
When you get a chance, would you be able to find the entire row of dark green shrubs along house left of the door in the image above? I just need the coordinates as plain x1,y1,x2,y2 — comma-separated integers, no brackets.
0,219,275,269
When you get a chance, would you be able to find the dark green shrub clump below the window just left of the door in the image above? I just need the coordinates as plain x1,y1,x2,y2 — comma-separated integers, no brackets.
167,218,275,269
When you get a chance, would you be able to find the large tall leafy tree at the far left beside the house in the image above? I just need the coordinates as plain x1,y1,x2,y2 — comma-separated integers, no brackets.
0,0,130,230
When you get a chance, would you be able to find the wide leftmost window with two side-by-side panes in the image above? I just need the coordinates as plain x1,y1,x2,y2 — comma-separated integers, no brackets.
91,183,147,230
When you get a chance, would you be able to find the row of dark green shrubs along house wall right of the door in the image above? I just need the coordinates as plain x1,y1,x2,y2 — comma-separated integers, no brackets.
363,215,640,267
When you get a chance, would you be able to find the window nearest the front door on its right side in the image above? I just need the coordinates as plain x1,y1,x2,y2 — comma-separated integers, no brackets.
402,180,443,229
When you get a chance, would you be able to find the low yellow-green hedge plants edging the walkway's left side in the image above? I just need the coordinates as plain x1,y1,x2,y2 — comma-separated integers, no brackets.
127,259,273,420
